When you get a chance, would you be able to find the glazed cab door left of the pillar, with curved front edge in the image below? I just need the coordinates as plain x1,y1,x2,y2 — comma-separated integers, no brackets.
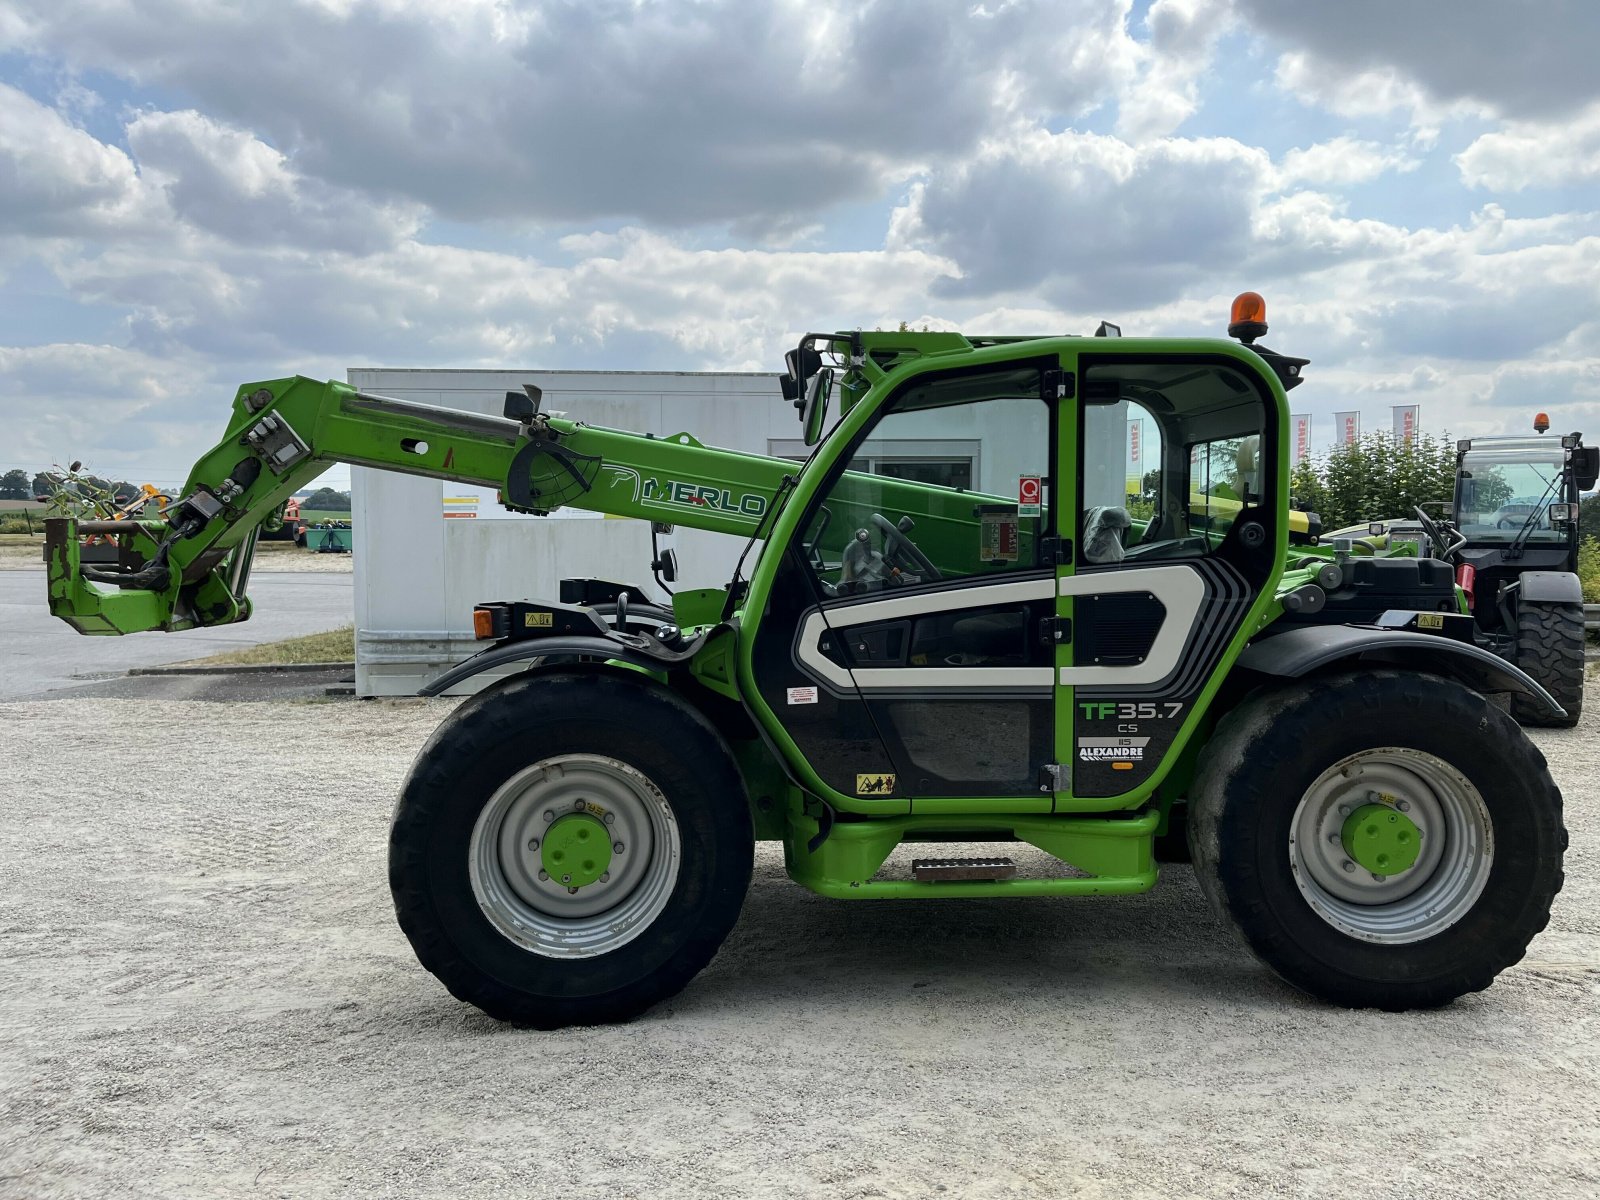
754,354,1074,813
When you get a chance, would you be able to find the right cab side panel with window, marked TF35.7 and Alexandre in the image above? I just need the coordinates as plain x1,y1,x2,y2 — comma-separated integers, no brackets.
1058,352,1285,811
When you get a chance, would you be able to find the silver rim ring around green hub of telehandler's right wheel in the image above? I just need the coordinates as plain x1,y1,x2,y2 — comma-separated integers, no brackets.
1288,746,1494,946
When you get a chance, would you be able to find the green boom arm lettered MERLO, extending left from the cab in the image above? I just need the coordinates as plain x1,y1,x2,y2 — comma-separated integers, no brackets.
45,378,795,634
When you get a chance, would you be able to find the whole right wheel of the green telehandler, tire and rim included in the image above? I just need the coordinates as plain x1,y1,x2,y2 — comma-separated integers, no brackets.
1189,670,1566,1011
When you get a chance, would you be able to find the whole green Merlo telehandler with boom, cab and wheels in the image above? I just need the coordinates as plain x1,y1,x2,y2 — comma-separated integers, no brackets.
46,293,1566,1027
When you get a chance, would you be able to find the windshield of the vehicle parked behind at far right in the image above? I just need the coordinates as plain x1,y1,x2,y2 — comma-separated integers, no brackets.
1456,438,1566,542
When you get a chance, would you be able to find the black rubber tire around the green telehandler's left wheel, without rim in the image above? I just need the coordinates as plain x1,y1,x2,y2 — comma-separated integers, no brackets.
389,670,754,1029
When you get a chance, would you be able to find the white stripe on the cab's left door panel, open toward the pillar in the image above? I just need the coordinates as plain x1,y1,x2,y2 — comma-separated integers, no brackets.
795,579,1056,691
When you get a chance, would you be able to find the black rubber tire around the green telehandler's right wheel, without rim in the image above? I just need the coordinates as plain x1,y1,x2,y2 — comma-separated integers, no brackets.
1189,670,1566,1011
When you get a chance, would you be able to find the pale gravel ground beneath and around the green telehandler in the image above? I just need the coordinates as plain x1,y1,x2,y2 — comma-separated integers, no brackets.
0,693,1600,1200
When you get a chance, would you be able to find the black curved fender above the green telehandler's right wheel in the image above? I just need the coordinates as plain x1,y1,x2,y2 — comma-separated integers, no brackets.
1237,626,1566,717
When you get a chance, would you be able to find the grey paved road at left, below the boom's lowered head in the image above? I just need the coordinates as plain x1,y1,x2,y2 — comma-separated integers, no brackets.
0,570,354,701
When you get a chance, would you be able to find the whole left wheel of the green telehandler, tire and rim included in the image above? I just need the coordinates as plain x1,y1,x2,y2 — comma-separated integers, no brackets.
389,670,754,1029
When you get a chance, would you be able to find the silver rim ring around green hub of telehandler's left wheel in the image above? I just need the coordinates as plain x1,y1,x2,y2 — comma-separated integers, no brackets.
467,754,682,958
